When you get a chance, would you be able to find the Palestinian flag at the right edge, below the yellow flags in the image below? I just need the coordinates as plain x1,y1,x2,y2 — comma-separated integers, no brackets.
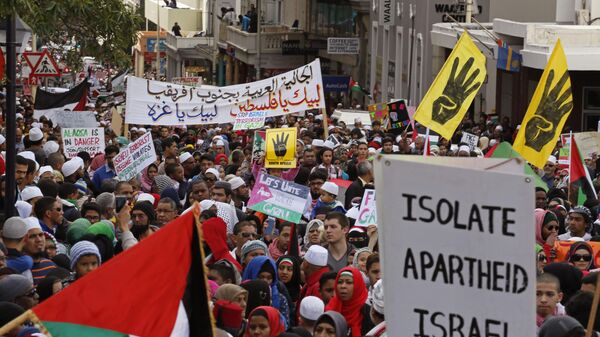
569,137,596,205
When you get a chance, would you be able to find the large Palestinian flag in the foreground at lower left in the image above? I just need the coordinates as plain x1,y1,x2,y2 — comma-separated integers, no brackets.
25,210,213,337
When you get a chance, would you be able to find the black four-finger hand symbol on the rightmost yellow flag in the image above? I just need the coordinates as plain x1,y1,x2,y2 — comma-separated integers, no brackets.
525,69,573,151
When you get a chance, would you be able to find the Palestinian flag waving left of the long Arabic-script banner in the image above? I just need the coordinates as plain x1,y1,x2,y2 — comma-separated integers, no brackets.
33,80,90,119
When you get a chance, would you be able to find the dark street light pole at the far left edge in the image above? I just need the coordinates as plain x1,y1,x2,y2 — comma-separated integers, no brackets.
4,11,17,218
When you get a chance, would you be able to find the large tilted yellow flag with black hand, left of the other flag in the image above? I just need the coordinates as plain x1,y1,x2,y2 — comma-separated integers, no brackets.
415,32,487,139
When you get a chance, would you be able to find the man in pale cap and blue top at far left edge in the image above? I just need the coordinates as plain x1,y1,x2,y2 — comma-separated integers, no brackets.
2,216,33,278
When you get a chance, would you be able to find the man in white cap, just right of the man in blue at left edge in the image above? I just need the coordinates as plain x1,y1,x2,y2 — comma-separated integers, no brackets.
23,217,56,286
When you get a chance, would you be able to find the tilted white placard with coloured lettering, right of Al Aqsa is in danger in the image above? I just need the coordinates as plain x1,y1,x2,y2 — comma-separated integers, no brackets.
113,132,156,181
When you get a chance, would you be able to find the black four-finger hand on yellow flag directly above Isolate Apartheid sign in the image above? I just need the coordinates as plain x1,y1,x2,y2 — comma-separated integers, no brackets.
431,57,481,124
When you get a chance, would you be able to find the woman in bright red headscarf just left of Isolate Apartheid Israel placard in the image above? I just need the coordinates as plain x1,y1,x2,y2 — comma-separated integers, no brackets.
325,267,373,337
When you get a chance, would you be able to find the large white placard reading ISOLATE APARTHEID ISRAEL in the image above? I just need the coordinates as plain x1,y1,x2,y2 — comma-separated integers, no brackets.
375,156,536,337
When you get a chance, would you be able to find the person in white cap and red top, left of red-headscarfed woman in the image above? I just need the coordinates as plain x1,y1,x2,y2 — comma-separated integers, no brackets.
300,245,329,298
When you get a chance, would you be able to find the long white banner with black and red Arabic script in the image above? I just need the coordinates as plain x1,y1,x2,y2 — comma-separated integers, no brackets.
125,59,325,125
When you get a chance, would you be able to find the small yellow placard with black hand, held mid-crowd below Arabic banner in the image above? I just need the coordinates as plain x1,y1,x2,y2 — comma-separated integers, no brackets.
265,128,298,168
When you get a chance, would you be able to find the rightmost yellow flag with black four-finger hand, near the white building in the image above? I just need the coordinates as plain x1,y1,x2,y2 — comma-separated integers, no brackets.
513,39,573,168
